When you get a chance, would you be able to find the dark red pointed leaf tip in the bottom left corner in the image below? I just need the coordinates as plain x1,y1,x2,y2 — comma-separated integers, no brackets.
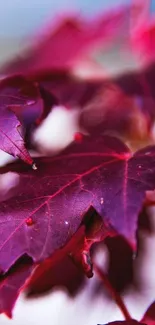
0,257,33,318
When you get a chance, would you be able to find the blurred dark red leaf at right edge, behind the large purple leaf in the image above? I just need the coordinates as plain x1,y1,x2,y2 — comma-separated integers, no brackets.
80,64,155,150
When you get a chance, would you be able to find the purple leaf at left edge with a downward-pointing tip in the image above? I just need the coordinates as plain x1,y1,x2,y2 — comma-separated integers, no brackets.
0,76,43,165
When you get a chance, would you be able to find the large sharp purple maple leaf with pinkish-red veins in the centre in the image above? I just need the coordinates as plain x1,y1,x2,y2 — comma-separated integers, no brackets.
0,136,155,272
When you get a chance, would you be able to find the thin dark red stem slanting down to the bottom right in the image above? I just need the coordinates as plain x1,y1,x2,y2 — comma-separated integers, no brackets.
93,263,132,320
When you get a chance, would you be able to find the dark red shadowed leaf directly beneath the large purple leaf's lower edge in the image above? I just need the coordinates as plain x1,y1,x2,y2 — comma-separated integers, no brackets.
27,207,116,295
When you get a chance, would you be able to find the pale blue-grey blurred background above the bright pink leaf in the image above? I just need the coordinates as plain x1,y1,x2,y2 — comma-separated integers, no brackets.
0,0,155,66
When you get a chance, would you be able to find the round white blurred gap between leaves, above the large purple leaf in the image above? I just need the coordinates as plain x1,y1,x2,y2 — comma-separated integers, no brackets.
32,106,81,155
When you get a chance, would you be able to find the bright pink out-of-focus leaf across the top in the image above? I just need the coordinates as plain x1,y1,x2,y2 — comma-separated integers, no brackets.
1,0,155,78
